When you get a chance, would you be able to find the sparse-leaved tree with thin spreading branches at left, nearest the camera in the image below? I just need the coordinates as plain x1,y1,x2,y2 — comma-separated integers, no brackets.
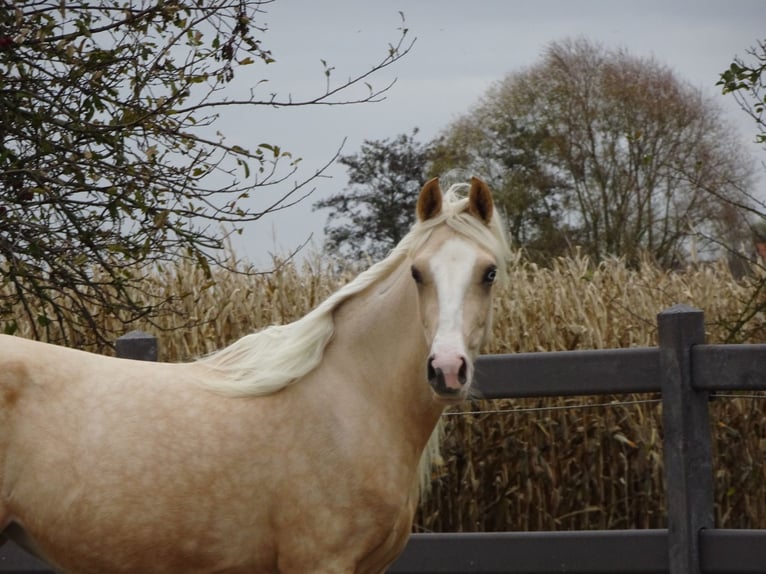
0,0,411,343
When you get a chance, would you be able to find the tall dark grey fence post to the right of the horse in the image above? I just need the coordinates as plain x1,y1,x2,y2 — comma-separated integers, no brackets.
657,305,714,574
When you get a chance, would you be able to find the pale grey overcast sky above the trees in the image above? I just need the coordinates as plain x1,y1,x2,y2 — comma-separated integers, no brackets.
217,0,766,266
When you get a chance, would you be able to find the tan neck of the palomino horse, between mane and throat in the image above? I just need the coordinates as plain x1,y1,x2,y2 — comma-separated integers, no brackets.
332,260,444,449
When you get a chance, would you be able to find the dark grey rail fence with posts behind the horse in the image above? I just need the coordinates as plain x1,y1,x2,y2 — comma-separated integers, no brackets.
0,305,766,574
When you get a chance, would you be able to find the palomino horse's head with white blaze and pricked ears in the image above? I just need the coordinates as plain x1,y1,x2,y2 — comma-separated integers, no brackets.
411,178,507,403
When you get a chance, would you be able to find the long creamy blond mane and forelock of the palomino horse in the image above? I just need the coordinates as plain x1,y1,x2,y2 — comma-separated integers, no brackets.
198,184,508,397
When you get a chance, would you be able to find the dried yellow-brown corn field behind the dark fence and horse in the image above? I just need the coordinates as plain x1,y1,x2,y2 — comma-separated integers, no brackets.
1,256,766,531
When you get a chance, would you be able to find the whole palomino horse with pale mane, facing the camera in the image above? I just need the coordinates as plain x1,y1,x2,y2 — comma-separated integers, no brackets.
0,178,507,574
